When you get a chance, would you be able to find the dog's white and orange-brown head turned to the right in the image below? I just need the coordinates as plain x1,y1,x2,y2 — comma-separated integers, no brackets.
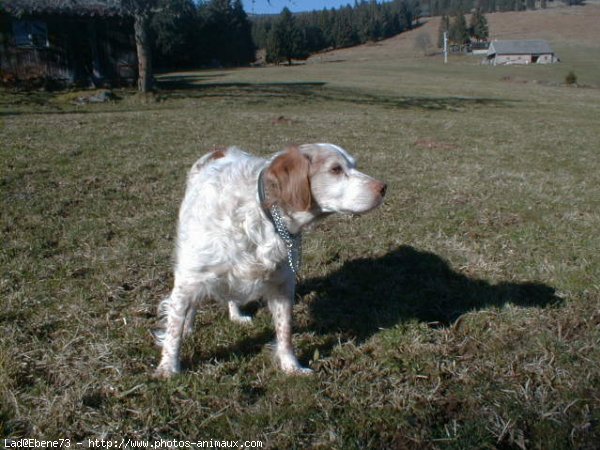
266,144,386,215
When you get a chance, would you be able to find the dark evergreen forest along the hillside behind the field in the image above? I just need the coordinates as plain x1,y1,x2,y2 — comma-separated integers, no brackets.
151,0,583,68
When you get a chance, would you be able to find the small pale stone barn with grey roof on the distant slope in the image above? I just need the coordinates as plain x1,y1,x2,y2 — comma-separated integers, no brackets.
486,40,558,66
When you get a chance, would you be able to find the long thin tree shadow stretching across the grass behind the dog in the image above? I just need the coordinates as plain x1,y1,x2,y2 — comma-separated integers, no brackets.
0,73,516,116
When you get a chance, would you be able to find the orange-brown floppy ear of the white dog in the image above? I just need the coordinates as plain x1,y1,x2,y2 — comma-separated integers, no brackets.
265,147,312,211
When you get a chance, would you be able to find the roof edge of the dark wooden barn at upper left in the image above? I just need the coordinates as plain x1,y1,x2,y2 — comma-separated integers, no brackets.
0,0,124,16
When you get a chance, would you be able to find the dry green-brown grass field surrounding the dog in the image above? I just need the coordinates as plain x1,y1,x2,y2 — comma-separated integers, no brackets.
0,5,600,449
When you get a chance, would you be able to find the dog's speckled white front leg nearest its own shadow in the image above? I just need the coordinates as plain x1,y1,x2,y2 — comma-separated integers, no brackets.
267,286,312,374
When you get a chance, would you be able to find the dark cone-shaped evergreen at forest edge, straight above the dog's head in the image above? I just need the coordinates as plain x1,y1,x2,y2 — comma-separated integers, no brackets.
267,8,308,65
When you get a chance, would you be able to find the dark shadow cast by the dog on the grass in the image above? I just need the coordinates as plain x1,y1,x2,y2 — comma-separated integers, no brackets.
298,246,561,353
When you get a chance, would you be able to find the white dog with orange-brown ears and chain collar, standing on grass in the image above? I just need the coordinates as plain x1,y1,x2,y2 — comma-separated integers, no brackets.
155,144,387,378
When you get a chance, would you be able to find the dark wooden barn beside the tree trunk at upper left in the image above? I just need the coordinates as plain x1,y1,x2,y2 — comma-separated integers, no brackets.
0,0,137,87
